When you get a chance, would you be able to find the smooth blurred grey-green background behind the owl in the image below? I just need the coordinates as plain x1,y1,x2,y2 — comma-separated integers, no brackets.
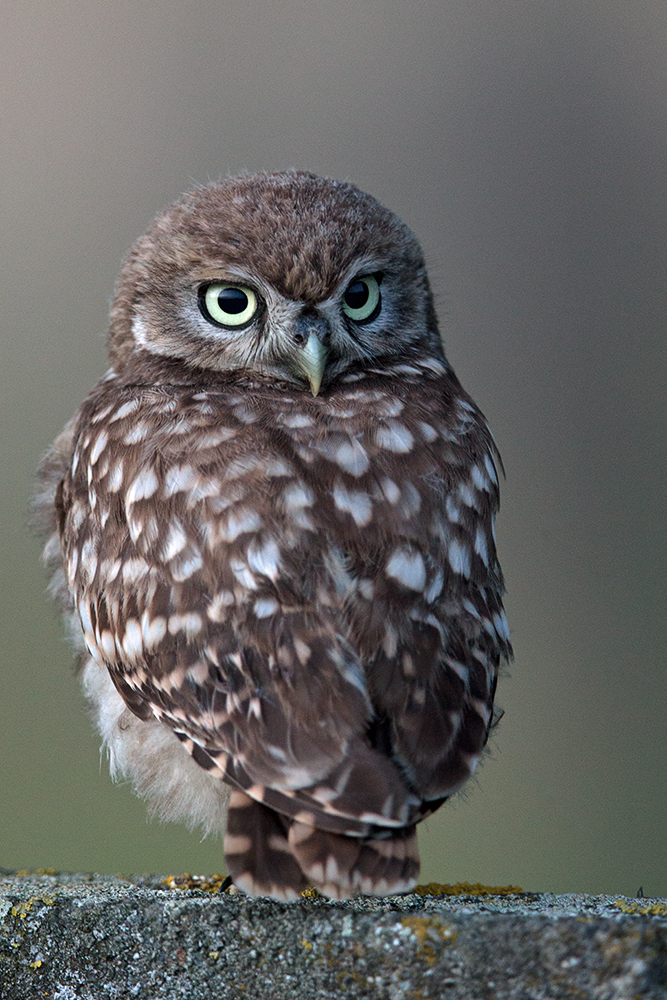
0,0,667,896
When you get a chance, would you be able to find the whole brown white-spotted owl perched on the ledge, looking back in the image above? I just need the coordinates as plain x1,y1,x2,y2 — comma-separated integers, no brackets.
38,171,511,900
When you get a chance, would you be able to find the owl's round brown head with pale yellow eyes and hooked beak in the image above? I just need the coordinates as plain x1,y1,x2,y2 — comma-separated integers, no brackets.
109,171,442,395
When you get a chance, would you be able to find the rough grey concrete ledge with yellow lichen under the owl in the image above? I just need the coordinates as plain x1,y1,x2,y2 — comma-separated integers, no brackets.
0,873,667,1000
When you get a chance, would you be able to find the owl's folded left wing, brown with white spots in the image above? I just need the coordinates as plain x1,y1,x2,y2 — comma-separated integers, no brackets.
62,382,420,891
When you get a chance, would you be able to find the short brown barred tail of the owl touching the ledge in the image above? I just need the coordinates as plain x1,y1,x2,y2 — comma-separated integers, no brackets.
225,791,419,900
